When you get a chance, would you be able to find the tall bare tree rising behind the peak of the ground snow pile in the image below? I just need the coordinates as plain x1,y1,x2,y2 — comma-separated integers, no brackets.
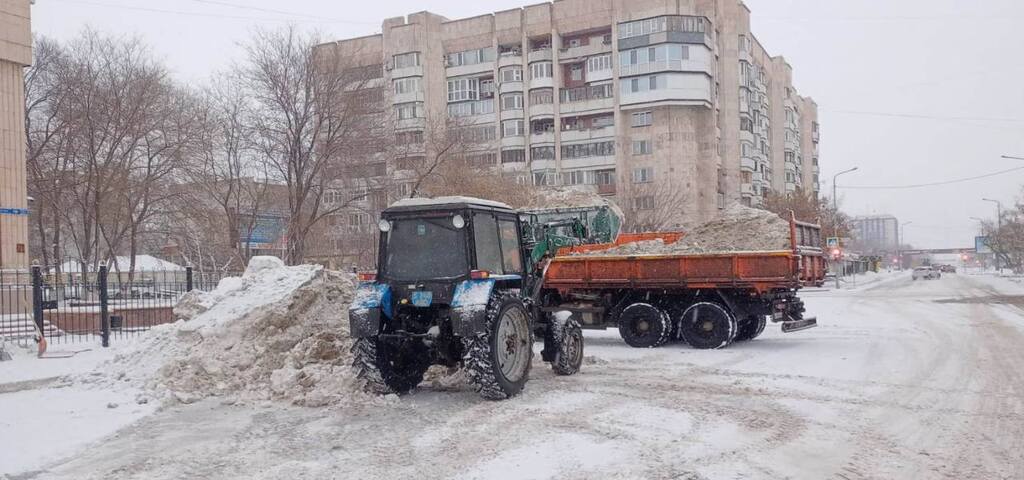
238,28,383,264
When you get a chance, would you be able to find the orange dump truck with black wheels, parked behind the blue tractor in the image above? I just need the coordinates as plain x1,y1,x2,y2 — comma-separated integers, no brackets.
541,215,825,349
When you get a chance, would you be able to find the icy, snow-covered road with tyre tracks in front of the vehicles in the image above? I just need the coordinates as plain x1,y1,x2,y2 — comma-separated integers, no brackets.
22,274,1024,480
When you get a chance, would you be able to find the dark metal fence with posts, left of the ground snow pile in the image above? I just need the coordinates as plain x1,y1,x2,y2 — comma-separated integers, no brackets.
0,266,239,347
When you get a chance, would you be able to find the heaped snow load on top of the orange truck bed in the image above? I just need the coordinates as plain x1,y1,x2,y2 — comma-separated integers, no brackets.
582,204,793,255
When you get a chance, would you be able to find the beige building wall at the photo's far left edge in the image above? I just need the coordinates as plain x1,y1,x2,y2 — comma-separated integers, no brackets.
0,0,32,270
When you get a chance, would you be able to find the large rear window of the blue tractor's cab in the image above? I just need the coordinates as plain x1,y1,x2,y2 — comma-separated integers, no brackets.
383,217,469,280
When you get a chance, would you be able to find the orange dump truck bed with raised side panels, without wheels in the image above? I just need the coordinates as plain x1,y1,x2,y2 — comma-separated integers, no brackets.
544,216,825,294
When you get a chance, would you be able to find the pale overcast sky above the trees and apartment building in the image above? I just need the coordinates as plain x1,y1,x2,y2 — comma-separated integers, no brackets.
33,0,1024,248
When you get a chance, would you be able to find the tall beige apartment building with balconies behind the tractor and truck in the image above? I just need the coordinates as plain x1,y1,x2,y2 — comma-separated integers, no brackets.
318,0,818,266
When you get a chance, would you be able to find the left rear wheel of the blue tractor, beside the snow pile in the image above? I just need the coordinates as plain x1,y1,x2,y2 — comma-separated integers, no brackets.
352,338,430,395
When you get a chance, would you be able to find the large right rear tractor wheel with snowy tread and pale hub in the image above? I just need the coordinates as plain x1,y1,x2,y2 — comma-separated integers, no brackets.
463,294,534,400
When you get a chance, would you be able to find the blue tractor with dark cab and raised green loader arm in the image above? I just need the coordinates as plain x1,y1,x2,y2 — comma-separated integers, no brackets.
349,198,620,399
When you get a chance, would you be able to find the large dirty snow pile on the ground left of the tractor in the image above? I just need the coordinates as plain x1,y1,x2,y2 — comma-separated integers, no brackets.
79,257,364,406
